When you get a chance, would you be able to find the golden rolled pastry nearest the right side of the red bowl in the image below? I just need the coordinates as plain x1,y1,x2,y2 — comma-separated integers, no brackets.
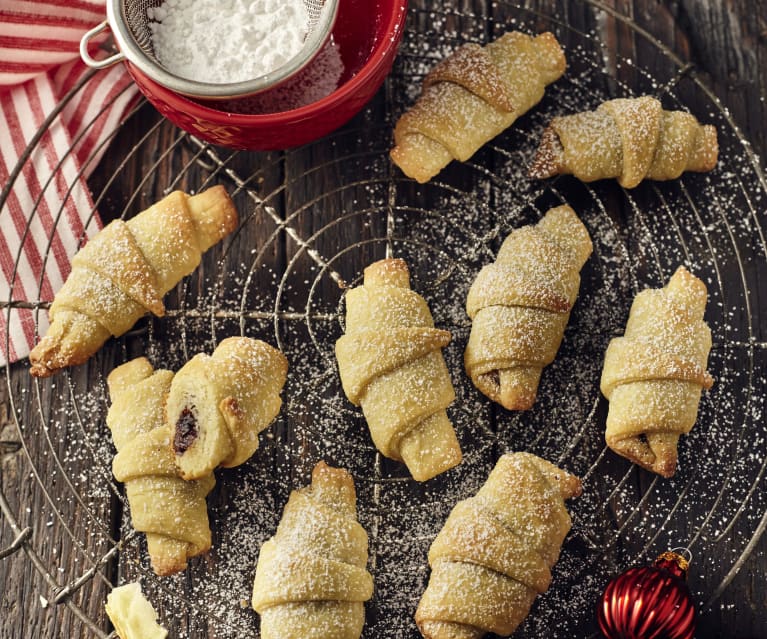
391,31,565,182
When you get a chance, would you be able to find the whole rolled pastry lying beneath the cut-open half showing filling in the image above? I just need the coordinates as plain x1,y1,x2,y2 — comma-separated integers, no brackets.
107,357,215,575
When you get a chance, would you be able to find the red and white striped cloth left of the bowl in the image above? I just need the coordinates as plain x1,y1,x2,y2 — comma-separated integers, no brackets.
0,0,137,364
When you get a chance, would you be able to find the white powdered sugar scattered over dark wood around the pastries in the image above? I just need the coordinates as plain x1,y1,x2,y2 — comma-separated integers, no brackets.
15,14,767,639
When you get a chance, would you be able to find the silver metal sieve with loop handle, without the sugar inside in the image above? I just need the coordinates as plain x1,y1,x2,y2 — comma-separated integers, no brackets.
80,0,338,100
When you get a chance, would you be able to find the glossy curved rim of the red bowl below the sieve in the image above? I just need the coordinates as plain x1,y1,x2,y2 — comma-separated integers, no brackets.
126,0,408,125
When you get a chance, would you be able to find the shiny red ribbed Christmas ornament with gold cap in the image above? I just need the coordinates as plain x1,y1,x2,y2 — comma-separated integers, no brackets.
597,551,697,639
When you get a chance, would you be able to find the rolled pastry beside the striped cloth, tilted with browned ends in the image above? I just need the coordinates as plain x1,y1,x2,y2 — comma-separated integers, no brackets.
29,186,237,377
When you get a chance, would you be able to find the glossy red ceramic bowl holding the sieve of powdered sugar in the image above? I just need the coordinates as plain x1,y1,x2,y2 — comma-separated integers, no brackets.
126,0,407,150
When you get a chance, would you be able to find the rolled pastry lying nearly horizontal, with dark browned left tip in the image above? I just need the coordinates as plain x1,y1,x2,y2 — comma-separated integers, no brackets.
530,96,719,189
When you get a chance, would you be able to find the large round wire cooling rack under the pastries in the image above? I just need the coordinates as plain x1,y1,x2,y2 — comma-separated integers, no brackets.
0,2,767,639
